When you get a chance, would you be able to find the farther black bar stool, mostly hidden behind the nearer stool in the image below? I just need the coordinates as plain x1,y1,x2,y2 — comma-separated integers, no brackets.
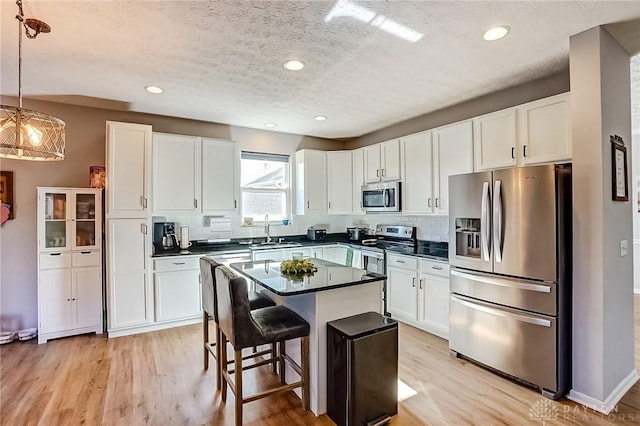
200,257,276,390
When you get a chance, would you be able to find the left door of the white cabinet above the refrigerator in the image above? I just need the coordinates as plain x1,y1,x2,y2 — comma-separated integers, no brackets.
473,108,517,171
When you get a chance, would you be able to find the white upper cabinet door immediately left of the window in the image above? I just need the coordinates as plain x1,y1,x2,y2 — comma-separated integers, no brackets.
202,138,240,215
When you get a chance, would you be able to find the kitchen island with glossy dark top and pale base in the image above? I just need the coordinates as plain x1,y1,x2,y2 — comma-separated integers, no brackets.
231,259,386,415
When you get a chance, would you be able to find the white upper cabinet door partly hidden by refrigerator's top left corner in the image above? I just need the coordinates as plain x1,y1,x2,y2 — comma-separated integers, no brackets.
433,120,473,214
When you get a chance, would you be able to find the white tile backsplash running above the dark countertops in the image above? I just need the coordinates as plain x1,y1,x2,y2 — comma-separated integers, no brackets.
153,214,449,241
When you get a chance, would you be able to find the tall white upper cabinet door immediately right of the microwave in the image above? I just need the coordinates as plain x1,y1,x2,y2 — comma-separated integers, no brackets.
401,132,435,214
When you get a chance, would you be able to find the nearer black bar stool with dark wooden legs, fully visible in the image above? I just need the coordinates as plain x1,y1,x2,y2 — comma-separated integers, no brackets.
215,266,309,425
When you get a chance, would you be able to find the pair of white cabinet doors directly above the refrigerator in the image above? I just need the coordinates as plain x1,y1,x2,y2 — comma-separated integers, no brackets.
473,93,572,171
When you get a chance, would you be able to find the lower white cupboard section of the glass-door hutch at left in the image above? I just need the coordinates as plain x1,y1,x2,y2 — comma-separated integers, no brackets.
38,251,102,343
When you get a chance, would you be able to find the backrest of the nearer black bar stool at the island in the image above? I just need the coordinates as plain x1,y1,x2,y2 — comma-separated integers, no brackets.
215,266,263,350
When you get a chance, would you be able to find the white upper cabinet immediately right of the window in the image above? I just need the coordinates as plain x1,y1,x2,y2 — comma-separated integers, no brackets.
296,149,327,215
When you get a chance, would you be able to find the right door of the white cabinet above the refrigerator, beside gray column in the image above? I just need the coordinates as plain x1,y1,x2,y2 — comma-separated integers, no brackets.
517,93,572,165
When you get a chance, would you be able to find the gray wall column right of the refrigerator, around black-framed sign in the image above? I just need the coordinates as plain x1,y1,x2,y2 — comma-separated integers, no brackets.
570,27,635,411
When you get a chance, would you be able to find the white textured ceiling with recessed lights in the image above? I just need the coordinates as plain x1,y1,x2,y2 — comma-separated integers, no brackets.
0,0,640,138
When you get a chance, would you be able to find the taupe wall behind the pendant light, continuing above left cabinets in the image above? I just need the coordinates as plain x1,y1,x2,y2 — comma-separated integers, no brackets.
0,97,344,330
